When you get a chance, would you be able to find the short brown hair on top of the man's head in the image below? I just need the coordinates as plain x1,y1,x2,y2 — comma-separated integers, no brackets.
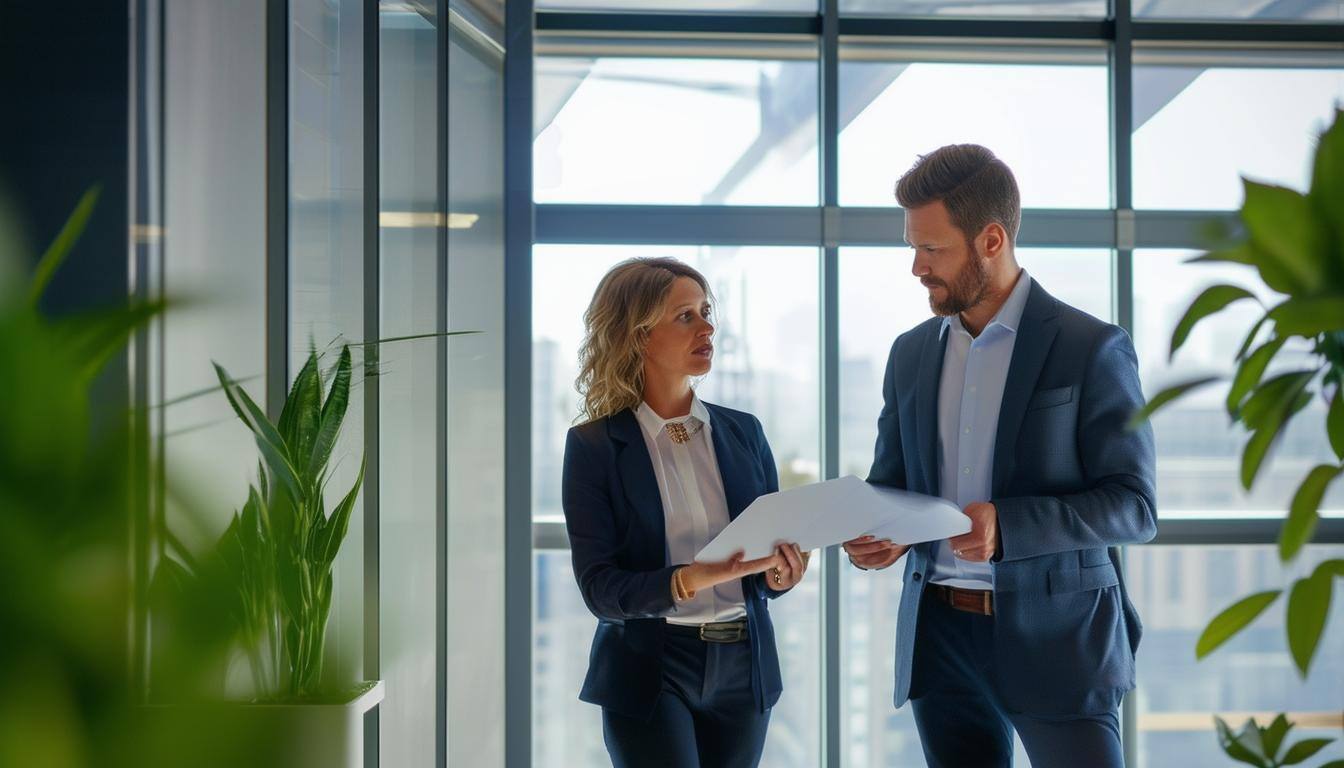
896,144,1021,242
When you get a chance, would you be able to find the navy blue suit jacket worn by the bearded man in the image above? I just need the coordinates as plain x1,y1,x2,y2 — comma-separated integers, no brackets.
868,281,1157,717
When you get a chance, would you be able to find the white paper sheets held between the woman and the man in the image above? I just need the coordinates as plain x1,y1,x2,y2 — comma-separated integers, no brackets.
695,475,970,562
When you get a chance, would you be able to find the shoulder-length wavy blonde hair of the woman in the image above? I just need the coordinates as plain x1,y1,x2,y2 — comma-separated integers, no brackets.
574,258,712,422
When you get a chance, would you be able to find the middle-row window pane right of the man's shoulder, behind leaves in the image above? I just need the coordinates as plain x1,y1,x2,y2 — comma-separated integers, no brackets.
1134,250,1344,516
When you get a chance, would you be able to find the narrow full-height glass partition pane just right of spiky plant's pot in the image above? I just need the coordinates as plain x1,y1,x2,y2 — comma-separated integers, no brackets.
376,3,440,765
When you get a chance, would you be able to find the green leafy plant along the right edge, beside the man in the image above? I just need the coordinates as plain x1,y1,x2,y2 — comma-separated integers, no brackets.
1134,110,1344,768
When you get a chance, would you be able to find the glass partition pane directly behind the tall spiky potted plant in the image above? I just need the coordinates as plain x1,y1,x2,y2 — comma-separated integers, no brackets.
289,0,364,681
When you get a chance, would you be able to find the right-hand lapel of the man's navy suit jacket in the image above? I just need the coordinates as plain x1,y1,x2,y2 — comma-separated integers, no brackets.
991,280,1059,496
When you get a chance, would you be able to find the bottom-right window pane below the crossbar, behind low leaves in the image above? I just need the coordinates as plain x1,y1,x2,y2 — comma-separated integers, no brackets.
1125,546,1344,768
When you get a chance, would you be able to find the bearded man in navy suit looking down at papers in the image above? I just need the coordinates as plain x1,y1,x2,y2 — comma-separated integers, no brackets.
844,144,1157,768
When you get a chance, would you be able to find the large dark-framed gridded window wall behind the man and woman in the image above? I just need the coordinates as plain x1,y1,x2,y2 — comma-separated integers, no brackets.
524,0,1344,768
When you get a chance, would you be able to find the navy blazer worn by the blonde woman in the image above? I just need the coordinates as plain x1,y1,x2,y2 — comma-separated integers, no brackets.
562,404,782,717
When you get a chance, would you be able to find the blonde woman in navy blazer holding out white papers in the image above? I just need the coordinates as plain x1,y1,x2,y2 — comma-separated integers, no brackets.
563,258,808,768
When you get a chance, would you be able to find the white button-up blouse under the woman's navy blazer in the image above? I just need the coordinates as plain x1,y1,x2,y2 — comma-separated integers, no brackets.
634,394,746,624
